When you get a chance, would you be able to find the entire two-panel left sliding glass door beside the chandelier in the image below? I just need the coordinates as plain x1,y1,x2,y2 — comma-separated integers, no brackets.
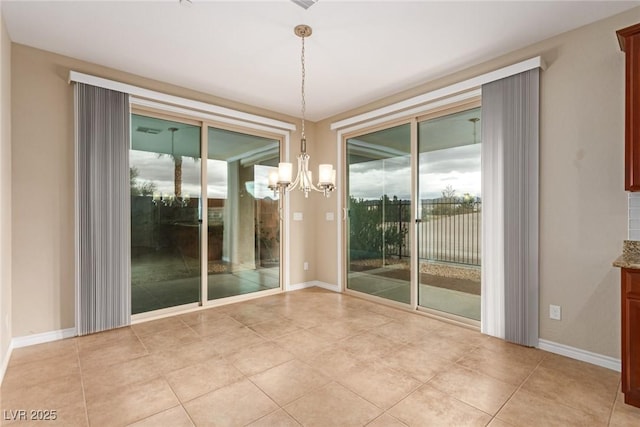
130,114,280,314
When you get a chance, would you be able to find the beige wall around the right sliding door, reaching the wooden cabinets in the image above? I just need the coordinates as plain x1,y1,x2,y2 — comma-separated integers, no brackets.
316,8,640,357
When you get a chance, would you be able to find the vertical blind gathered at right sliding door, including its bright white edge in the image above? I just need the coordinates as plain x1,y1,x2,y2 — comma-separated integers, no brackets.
482,68,540,346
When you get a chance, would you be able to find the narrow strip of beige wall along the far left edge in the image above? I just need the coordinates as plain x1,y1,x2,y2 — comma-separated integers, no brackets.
0,10,11,372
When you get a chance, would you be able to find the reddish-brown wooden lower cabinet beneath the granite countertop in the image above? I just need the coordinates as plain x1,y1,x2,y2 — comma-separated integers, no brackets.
621,268,640,407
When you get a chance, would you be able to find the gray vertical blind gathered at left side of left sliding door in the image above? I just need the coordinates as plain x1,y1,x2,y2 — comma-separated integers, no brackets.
75,83,131,335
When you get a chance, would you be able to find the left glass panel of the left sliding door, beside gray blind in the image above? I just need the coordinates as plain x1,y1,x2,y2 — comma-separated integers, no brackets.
129,114,201,314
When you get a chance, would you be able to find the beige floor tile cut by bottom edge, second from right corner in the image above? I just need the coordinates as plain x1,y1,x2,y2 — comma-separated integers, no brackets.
496,389,607,427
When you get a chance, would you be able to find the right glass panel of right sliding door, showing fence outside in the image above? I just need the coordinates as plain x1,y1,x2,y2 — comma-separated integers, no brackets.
416,108,482,320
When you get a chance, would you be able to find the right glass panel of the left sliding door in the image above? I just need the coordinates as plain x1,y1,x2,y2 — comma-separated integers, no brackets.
207,128,280,300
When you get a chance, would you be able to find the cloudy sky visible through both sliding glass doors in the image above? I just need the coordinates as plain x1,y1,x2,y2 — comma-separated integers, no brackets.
130,140,481,200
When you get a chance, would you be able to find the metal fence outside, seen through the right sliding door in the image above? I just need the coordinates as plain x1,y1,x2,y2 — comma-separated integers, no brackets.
366,197,482,266
